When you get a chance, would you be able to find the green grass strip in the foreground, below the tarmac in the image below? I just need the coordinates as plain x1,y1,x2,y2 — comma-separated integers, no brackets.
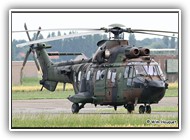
12,114,178,128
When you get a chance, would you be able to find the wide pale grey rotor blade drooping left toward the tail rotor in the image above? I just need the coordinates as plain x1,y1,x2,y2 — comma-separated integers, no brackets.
16,31,105,47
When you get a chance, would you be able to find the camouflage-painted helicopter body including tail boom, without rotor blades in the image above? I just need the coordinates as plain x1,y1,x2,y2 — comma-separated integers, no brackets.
35,40,168,113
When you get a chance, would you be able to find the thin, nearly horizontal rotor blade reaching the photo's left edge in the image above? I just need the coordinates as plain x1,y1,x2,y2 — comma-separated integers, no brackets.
12,28,102,33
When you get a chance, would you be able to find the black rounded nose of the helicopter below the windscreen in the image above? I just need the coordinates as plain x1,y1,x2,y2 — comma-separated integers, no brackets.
141,80,166,103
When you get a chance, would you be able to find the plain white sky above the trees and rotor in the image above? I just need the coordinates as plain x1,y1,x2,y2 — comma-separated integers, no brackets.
12,10,178,40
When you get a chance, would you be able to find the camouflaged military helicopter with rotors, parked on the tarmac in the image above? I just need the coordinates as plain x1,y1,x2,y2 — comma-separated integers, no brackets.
14,24,177,114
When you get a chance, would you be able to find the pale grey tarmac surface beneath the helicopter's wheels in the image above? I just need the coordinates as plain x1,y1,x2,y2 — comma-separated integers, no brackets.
11,97,178,116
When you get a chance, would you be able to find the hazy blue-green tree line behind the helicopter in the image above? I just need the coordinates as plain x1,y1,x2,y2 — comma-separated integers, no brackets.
12,31,178,62
